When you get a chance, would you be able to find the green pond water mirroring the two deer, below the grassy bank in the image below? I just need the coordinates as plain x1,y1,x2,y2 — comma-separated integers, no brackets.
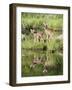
22,50,63,77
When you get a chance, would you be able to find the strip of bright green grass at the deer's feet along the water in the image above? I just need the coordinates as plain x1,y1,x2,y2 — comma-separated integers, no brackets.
21,36,63,50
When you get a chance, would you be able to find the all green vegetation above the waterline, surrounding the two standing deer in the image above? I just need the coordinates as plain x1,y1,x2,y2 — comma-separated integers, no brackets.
21,13,63,49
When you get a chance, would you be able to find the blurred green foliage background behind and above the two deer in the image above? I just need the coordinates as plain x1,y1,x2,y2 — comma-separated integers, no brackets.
21,12,63,34
